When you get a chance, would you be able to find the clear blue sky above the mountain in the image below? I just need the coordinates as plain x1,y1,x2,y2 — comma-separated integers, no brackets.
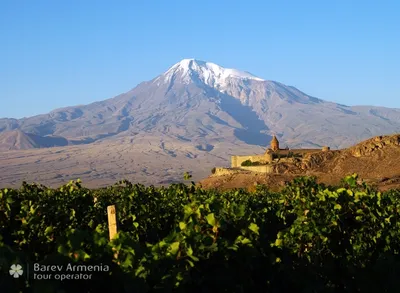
0,0,400,118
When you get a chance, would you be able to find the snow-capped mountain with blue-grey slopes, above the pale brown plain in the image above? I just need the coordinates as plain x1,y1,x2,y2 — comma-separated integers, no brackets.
0,59,400,149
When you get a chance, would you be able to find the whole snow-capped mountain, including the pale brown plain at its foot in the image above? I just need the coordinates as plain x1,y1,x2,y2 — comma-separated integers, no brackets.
0,59,400,184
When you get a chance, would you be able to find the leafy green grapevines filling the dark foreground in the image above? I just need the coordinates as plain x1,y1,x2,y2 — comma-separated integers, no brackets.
0,175,400,293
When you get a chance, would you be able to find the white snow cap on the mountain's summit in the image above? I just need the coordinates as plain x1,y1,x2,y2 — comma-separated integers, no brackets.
158,59,264,88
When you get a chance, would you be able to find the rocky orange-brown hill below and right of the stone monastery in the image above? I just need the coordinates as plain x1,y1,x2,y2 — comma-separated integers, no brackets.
199,134,400,190
